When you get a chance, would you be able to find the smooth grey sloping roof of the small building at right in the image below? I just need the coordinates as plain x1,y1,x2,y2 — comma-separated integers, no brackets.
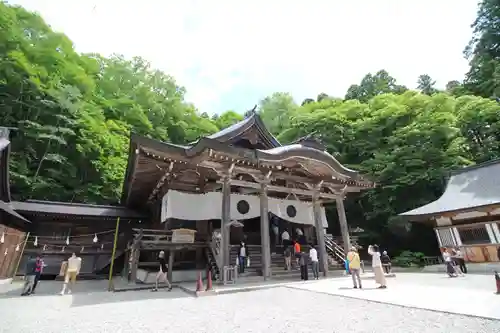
400,160,500,219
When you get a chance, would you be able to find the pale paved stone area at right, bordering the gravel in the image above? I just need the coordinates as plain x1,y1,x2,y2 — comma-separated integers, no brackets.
290,274,500,320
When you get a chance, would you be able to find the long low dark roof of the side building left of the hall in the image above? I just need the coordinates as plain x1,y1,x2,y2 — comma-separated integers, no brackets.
12,200,146,219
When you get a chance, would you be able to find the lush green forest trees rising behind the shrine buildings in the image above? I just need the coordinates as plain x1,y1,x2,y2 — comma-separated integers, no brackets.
0,0,500,252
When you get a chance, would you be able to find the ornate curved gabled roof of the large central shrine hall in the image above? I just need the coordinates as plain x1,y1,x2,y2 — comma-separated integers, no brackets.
121,113,375,204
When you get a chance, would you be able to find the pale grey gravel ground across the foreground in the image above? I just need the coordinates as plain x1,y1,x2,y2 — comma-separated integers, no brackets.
0,287,500,333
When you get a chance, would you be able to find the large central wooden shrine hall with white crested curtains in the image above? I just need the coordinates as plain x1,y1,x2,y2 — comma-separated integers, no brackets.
122,112,374,279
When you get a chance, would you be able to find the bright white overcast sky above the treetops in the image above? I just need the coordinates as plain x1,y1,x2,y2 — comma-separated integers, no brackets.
8,0,478,114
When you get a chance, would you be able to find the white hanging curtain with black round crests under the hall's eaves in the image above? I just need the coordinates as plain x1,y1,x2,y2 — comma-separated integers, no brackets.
161,190,328,228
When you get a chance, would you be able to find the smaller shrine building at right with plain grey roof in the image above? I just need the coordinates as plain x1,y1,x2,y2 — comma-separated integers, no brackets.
400,160,500,262
